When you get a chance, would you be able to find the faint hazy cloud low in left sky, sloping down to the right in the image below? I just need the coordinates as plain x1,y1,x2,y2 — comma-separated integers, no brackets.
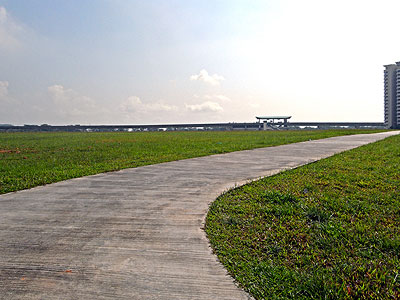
47,84,97,117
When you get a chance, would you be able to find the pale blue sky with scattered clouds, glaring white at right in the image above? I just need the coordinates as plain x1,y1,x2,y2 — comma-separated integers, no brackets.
0,0,400,125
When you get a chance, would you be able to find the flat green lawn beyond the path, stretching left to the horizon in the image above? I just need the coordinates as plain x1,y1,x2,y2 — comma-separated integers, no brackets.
0,130,386,194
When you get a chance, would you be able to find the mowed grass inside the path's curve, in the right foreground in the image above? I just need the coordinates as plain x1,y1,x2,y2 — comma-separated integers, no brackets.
206,136,400,299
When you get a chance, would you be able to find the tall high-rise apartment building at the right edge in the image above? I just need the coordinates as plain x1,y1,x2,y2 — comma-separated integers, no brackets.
384,62,400,128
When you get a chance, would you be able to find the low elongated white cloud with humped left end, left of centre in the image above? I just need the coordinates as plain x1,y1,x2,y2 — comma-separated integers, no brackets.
119,96,178,114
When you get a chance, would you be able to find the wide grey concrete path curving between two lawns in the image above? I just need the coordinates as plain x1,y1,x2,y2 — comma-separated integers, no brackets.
0,132,398,300
